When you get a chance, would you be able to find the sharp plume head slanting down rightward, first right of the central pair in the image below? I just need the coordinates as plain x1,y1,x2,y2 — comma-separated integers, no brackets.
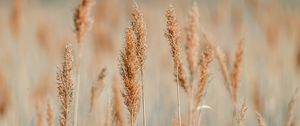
165,5,190,94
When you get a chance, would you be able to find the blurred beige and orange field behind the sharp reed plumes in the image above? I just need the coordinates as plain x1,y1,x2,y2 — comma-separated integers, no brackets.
0,0,300,126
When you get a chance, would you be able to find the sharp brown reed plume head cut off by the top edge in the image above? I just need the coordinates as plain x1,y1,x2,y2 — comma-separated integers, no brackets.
73,0,93,44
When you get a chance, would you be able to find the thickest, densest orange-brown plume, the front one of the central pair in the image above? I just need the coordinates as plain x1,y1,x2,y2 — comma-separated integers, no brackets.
121,27,141,126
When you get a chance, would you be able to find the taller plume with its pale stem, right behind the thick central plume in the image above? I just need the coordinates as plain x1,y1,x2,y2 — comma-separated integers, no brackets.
131,5,146,126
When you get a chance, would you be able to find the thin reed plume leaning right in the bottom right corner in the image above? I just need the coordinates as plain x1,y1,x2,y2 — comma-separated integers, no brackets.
285,88,299,126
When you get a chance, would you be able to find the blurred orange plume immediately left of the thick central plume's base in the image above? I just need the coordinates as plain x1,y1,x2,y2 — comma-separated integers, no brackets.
113,77,125,126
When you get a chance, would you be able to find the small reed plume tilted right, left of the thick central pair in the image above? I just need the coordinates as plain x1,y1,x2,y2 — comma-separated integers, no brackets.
90,68,106,112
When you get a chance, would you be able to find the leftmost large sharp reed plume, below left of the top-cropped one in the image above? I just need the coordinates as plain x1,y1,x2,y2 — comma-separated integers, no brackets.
57,44,73,126
